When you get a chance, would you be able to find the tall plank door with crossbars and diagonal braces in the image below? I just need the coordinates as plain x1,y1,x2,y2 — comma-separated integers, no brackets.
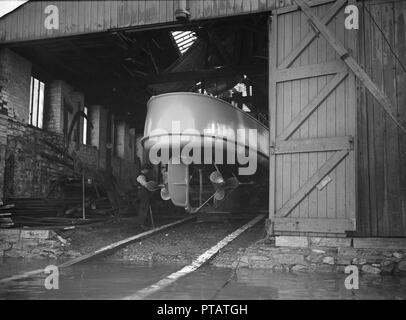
269,0,356,234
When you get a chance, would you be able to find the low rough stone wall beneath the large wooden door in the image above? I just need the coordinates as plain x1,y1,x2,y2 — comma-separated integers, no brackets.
239,236,406,275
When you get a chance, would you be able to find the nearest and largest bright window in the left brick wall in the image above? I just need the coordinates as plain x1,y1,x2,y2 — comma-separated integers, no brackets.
28,77,45,129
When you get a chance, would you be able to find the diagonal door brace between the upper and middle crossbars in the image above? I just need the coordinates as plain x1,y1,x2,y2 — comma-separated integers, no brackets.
277,72,348,140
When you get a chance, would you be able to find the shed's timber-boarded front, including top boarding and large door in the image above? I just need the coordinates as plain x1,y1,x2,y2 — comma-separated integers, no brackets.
0,0,406,237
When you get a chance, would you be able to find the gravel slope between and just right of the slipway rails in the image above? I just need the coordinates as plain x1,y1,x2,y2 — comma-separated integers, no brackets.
108,219,263,267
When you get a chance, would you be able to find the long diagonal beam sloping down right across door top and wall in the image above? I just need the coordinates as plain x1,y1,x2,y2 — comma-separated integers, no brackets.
294,0,406,133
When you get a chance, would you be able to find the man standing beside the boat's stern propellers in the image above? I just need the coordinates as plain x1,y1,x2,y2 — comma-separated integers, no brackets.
137,164,158,229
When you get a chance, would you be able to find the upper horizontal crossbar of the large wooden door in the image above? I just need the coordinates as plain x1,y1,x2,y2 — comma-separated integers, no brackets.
275,60,347,82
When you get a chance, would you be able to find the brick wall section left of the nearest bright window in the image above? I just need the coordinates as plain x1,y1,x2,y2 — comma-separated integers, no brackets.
0,48,31,123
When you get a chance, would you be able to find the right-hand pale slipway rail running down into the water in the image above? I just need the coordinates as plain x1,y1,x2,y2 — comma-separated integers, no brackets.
124,214,265,300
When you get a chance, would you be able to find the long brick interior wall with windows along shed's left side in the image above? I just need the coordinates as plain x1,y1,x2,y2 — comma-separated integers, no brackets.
0,49,141,200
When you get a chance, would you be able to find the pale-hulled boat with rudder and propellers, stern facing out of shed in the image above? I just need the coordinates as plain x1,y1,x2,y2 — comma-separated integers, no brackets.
141,92,269,212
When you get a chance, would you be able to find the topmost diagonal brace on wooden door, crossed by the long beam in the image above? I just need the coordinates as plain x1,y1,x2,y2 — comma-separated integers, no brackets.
278,0,347,69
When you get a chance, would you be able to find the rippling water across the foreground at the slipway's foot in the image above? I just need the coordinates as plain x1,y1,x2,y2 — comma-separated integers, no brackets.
0,259,406,300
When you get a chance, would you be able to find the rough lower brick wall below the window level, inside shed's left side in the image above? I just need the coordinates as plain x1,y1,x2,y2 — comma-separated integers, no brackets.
0,119,138,198
